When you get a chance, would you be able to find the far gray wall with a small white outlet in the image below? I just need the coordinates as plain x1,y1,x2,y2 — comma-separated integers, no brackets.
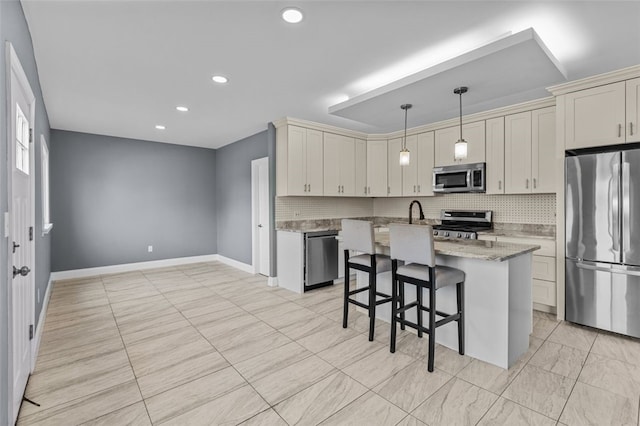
51,130,217,271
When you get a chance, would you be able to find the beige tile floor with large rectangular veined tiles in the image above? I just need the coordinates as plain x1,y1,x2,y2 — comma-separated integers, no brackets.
18,262,640,426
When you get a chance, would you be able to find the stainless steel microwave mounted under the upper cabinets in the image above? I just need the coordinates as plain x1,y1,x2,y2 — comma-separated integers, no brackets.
433,163,486,192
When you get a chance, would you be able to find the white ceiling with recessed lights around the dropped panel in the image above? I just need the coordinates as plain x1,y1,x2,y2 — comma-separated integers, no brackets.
22,0,640,148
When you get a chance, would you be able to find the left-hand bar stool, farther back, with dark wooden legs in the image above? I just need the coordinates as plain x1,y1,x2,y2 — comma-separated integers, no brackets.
342,219,391,341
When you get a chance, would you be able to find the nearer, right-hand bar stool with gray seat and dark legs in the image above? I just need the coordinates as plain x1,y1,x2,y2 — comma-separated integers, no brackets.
389,224,465,372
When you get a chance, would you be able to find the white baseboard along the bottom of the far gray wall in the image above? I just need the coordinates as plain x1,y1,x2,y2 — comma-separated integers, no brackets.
51,254,220,281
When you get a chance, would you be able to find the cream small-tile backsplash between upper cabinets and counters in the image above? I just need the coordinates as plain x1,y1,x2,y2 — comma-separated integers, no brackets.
276,194,556,225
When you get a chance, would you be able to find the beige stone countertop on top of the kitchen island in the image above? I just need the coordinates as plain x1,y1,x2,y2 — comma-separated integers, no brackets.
375,232,540,262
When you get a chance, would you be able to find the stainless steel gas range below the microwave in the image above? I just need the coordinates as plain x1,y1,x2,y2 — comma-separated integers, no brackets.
433,210,493,240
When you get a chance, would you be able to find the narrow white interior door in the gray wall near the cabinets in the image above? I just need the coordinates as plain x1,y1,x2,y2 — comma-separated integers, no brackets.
251,157,271,277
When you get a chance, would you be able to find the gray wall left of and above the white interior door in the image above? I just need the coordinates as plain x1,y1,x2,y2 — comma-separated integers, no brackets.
216,130,266,265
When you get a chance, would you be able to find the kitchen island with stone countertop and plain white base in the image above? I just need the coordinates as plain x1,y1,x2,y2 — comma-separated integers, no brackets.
356,232,539,368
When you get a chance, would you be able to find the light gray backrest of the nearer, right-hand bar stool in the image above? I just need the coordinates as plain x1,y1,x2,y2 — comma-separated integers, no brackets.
389,223,436,267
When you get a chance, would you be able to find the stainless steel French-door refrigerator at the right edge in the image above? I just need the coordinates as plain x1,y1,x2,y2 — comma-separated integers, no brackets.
565,149,640,337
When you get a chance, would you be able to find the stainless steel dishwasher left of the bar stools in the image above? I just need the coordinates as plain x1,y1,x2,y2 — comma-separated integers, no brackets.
304,231,338,291
